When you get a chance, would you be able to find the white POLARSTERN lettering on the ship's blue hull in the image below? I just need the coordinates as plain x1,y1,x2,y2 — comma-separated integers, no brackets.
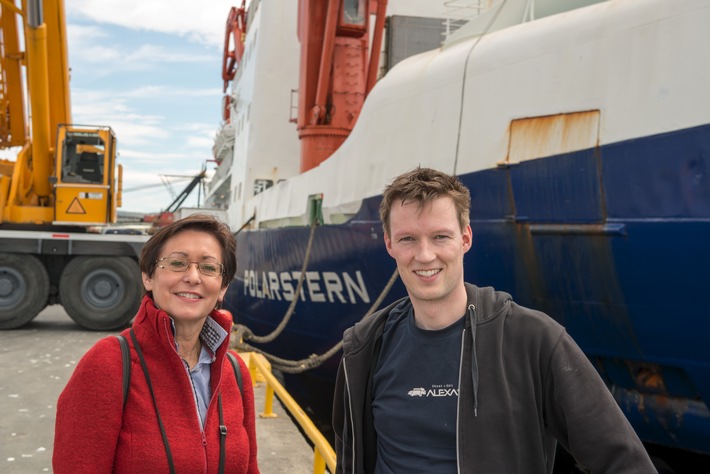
244,270,370,304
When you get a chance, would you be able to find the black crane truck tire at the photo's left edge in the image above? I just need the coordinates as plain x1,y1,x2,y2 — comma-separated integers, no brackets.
0,253,49,329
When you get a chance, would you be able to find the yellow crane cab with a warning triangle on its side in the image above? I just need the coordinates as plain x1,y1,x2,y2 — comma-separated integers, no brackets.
54,125,116,225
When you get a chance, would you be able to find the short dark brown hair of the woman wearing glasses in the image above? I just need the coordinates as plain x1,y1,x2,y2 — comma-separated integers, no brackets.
138,214,237,288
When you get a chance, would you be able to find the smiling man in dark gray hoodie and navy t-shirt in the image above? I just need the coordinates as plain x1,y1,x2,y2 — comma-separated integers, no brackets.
333,168,657,474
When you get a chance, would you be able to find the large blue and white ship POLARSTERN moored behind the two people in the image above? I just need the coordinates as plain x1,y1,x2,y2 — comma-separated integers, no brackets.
206,0,710,462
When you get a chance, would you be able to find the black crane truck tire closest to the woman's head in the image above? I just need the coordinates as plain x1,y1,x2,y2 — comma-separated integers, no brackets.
59,257,143,331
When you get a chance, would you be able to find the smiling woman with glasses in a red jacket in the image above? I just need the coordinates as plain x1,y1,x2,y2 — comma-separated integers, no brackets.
52,215,259,474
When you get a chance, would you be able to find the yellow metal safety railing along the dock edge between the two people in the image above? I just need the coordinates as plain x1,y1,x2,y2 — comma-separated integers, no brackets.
245,352,335,474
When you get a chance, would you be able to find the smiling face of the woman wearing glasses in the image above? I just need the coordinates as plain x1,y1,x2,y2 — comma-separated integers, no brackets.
143,229,227,322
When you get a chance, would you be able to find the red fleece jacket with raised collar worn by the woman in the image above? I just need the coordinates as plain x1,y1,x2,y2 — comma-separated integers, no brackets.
52,296,259,474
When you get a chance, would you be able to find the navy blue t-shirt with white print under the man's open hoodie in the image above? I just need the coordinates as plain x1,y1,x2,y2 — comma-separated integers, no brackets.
372,312,464,474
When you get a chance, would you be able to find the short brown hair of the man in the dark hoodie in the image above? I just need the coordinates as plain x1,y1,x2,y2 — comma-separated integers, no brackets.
380,168,471,235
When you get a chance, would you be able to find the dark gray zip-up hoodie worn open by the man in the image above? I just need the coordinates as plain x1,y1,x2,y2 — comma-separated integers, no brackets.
333,284,657,474
